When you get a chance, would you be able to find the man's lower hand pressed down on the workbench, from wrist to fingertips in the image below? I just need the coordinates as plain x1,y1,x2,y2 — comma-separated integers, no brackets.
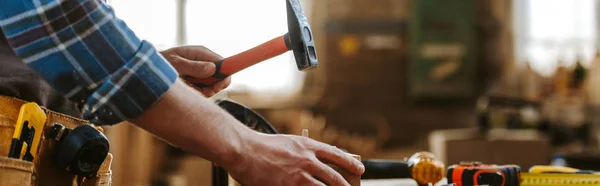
224,133,365,186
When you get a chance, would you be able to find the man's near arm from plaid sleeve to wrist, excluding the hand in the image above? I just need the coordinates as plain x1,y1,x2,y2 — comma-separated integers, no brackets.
0,0,248,164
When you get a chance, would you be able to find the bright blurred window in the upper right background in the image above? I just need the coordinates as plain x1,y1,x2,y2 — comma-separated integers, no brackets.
516,0,598,76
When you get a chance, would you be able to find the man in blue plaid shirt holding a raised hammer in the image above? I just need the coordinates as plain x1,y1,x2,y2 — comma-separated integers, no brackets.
0,0,364,186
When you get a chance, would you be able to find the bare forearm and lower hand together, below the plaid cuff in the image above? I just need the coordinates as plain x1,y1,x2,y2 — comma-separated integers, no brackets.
131,81,364,186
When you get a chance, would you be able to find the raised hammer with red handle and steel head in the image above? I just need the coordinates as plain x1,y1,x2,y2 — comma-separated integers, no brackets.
188,0,318,87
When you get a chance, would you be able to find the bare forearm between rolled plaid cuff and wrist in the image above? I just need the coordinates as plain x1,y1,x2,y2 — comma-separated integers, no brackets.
130,80,254,165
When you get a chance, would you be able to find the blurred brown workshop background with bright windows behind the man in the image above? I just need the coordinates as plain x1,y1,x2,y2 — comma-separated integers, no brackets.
101,0,600,186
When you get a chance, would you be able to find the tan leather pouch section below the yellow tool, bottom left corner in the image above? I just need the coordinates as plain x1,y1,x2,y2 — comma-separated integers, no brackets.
0,157,33,186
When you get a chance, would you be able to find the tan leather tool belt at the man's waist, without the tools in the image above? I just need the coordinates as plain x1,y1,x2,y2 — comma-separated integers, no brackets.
0,96,112,186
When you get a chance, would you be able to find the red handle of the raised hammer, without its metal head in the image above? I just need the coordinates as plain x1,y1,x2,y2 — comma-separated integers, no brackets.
188,34,291,87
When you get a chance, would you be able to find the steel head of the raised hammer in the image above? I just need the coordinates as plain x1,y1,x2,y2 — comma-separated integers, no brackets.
286,0,319,71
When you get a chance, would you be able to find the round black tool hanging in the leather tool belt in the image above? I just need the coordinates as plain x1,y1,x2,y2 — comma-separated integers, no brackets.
46,123,110,179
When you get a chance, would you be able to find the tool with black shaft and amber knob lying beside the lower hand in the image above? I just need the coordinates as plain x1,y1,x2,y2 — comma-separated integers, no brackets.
361,152,445,185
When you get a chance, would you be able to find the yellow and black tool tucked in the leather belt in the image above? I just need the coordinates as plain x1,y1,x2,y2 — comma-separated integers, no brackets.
8,103,47,161
